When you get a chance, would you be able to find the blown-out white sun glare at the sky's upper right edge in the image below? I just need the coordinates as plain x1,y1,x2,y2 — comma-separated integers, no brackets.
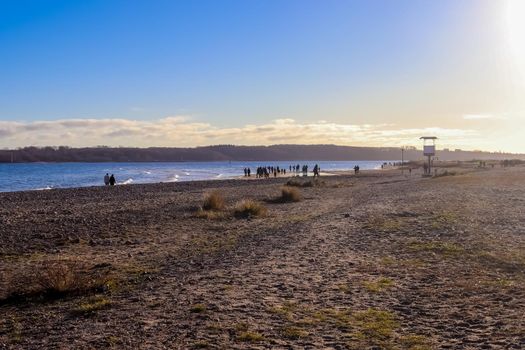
507,0,525,84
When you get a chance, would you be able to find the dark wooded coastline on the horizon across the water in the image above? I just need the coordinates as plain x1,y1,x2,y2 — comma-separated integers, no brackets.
0,145,525,163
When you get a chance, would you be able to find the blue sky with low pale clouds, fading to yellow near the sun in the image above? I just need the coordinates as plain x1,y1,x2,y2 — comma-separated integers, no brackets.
0,0,525,151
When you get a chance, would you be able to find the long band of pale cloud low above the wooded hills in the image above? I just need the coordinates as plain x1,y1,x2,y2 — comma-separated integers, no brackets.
0,116,478,148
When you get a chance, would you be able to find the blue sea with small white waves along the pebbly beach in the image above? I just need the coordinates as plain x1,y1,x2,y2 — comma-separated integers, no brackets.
0,161,383,192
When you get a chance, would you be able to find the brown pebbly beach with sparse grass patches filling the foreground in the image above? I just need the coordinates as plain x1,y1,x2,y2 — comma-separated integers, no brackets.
0,167,525,350
